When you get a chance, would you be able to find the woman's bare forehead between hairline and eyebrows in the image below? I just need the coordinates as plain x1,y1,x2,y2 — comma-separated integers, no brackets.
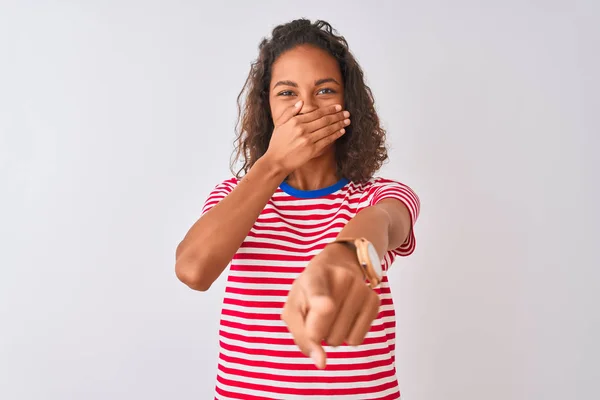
271,45,341,84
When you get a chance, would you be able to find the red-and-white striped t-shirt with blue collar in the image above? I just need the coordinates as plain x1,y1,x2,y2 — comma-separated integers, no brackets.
202,178,420,400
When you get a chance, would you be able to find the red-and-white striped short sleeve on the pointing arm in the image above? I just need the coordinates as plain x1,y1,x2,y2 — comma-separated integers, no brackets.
369,178,421,257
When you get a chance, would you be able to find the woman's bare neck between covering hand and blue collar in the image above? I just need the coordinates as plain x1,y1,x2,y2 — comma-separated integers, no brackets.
286,151,341,190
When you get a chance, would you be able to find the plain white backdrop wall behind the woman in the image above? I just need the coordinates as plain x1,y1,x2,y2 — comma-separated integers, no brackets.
0,0,600,400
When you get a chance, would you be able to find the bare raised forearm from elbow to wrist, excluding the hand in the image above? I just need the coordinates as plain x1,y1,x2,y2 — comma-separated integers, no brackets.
175,159,285,290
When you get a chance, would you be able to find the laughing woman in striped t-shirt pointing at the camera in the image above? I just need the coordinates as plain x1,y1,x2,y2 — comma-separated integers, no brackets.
176,19,419,400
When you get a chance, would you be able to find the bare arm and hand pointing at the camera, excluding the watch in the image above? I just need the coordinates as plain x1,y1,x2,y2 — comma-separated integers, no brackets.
281,198,412,368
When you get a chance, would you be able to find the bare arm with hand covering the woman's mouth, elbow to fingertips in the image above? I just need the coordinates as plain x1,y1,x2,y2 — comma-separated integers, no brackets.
175,101,349,291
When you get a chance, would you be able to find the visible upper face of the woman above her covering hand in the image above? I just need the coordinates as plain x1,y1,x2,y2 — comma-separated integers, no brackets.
269,45,344,120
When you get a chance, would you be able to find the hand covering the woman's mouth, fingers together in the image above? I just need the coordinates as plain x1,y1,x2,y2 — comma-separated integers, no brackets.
264,100,350,174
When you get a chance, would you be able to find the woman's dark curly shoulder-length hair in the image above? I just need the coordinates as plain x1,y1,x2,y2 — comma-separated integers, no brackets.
231,19,388,182
